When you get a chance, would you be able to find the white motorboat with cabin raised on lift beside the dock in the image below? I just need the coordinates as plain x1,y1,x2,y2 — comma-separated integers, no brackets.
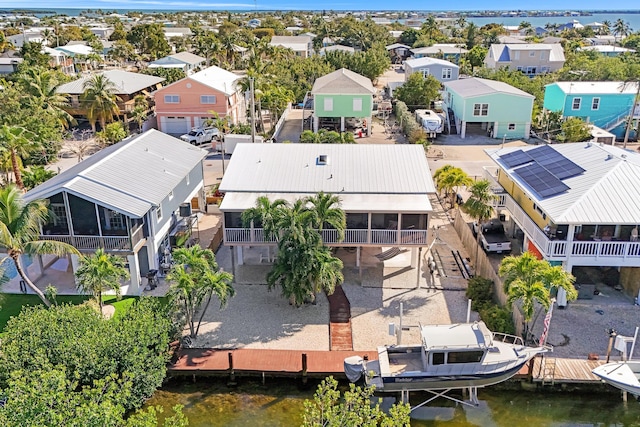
345,322,551,392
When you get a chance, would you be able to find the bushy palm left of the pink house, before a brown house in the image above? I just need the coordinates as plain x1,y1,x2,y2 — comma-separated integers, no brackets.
81,74,121,132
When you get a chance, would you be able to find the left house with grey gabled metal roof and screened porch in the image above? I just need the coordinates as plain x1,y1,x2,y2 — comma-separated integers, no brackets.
24,129,207,295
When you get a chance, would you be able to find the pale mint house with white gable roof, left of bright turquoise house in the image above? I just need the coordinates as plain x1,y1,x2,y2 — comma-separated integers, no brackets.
443,77,535,139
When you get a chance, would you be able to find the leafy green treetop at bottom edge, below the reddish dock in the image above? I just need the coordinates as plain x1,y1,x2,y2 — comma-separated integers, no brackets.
302,377,411,427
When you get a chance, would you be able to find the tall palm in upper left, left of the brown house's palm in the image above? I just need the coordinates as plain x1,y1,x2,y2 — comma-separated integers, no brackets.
18,67,76,128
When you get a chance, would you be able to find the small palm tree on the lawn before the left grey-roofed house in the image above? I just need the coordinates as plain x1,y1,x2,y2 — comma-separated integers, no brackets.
75,248,129,313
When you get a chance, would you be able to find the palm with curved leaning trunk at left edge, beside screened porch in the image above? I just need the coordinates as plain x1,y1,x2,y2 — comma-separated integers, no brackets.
0,185,80,307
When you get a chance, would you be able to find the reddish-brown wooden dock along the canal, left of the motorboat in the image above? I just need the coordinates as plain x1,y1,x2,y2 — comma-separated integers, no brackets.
167,348,378,377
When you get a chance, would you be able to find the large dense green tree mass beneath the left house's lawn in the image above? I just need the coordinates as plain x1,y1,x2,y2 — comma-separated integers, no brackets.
0,298,171,410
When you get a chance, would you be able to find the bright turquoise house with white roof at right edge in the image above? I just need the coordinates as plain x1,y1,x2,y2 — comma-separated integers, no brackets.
544,82,640,138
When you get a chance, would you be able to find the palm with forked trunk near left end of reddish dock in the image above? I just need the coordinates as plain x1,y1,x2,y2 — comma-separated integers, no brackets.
167,245,235,338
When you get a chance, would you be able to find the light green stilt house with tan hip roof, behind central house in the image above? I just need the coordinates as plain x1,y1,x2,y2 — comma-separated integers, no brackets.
311,68,376,135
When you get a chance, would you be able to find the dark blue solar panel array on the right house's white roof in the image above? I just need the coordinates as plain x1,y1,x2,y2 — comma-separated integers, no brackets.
499,145,585,198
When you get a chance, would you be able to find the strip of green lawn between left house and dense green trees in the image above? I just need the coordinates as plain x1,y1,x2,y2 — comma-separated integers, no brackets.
0,293,166,332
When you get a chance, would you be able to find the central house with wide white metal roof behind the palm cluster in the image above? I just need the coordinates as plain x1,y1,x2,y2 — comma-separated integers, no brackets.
219,144,436,263
